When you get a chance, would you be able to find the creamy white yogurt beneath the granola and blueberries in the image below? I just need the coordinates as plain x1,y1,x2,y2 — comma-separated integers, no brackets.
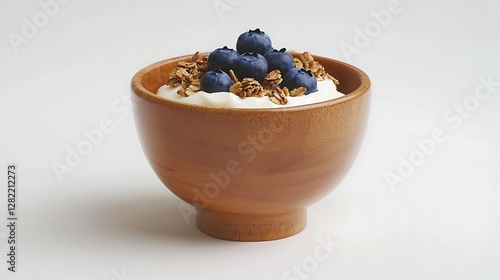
158,79,344,109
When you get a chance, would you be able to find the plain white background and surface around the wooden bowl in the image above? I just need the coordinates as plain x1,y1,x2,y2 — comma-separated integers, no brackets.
0,0,500,280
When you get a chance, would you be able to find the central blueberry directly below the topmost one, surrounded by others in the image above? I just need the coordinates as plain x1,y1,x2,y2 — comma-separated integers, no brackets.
233,52,267,82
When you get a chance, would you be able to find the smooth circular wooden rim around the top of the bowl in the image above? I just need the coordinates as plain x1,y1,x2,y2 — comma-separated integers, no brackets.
131,51,371,112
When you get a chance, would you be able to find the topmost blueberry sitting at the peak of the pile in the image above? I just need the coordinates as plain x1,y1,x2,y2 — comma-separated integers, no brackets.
236,28,273,55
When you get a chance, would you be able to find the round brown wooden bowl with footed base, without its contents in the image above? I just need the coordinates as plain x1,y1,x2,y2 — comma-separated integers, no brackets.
131,54,370,241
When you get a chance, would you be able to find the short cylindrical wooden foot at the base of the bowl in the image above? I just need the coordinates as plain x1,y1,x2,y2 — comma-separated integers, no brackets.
196,208,307,241
